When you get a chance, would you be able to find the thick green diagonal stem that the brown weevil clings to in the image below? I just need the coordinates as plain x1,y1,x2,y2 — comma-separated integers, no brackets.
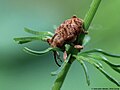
52,0,101,90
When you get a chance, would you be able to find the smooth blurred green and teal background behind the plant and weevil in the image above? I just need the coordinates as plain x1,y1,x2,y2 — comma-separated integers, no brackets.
0,0,120,90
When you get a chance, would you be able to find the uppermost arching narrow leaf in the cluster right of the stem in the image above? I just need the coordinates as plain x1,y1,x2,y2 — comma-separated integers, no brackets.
83,49,120,58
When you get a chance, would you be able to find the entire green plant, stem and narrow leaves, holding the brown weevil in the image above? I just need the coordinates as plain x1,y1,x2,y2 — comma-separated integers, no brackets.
14,0,120,90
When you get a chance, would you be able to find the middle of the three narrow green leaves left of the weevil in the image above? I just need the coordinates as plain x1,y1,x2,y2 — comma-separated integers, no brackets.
14,37,47,44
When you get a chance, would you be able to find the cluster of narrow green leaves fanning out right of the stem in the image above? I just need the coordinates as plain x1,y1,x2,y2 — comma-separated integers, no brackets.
73,49,120,86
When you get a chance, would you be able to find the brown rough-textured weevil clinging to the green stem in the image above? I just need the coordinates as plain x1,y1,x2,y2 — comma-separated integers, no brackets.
47,16,86,66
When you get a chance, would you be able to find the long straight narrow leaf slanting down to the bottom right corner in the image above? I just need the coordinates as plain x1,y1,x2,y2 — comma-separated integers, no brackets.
74,56,120,86
